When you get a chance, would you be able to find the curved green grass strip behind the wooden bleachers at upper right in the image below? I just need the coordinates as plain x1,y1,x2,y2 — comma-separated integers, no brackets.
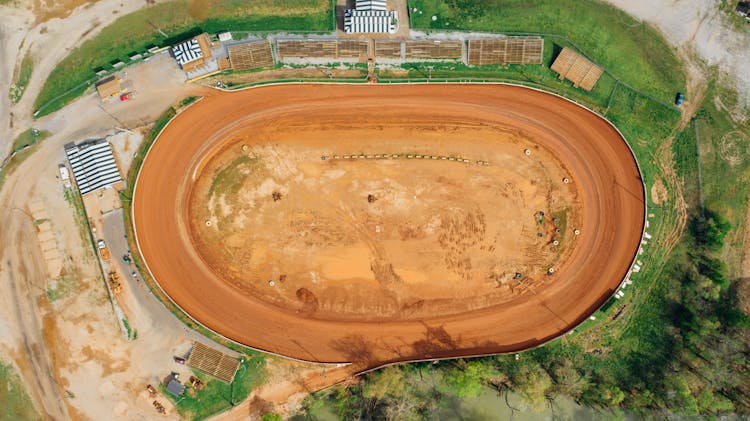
409,0,685,103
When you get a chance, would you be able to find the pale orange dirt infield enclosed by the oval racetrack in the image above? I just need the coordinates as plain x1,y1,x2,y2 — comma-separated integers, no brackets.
190,115,582,320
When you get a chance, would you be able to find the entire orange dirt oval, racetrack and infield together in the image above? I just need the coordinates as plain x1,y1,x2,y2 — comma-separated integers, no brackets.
133,84,645,369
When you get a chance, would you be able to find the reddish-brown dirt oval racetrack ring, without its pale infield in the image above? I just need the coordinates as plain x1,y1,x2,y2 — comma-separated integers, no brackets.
133,84,645,370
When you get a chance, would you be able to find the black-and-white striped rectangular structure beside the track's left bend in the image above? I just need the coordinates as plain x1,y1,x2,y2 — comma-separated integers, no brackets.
65,139,122,195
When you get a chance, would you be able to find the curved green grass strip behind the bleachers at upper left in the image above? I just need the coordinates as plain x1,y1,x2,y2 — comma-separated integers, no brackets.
34,0,334,117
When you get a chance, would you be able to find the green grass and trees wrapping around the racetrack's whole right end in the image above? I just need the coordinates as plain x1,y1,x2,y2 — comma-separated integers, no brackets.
296,0,750,419
